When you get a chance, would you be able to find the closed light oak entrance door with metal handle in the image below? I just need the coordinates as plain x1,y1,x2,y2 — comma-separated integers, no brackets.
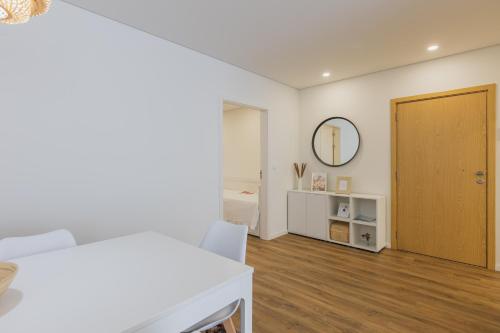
393,85,495,267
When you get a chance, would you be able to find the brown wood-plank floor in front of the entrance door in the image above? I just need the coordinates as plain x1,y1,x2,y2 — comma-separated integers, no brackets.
235,235,500,333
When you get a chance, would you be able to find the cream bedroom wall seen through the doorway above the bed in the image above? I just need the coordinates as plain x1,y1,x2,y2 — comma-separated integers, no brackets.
224,108,261,191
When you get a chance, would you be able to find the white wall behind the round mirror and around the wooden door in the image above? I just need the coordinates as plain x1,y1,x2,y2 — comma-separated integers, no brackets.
300,46,500,268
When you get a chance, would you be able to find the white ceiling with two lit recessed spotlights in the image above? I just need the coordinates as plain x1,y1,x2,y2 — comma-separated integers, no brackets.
62,0,500,88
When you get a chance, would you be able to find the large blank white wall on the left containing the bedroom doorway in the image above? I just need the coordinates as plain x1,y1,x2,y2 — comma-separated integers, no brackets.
0,1,298,243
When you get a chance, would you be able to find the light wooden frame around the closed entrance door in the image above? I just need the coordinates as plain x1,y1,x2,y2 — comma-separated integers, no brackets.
391,84,496,270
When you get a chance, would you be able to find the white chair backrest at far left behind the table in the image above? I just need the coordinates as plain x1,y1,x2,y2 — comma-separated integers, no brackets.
0,230,76,261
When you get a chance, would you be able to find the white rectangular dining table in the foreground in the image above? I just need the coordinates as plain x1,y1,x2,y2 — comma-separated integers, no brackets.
0,232,253,333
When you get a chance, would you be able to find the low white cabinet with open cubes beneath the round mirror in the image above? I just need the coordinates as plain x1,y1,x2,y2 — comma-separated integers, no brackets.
288,190,386,252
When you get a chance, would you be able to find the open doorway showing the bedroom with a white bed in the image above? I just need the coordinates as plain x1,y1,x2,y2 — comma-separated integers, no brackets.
220,101,267,238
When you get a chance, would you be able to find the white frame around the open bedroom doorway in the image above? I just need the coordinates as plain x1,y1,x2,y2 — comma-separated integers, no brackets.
218,98,272,240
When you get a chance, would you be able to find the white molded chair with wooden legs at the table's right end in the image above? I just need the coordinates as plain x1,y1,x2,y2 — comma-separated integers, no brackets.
184,221,248,333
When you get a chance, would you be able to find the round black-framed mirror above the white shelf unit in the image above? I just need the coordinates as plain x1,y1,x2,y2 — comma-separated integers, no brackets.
312,117,361,167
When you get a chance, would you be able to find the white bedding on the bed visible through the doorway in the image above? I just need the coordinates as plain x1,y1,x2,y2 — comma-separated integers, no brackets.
224,190,259,229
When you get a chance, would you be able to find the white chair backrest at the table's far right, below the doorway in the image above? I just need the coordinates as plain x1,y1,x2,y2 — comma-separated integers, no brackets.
200,221,248,263
